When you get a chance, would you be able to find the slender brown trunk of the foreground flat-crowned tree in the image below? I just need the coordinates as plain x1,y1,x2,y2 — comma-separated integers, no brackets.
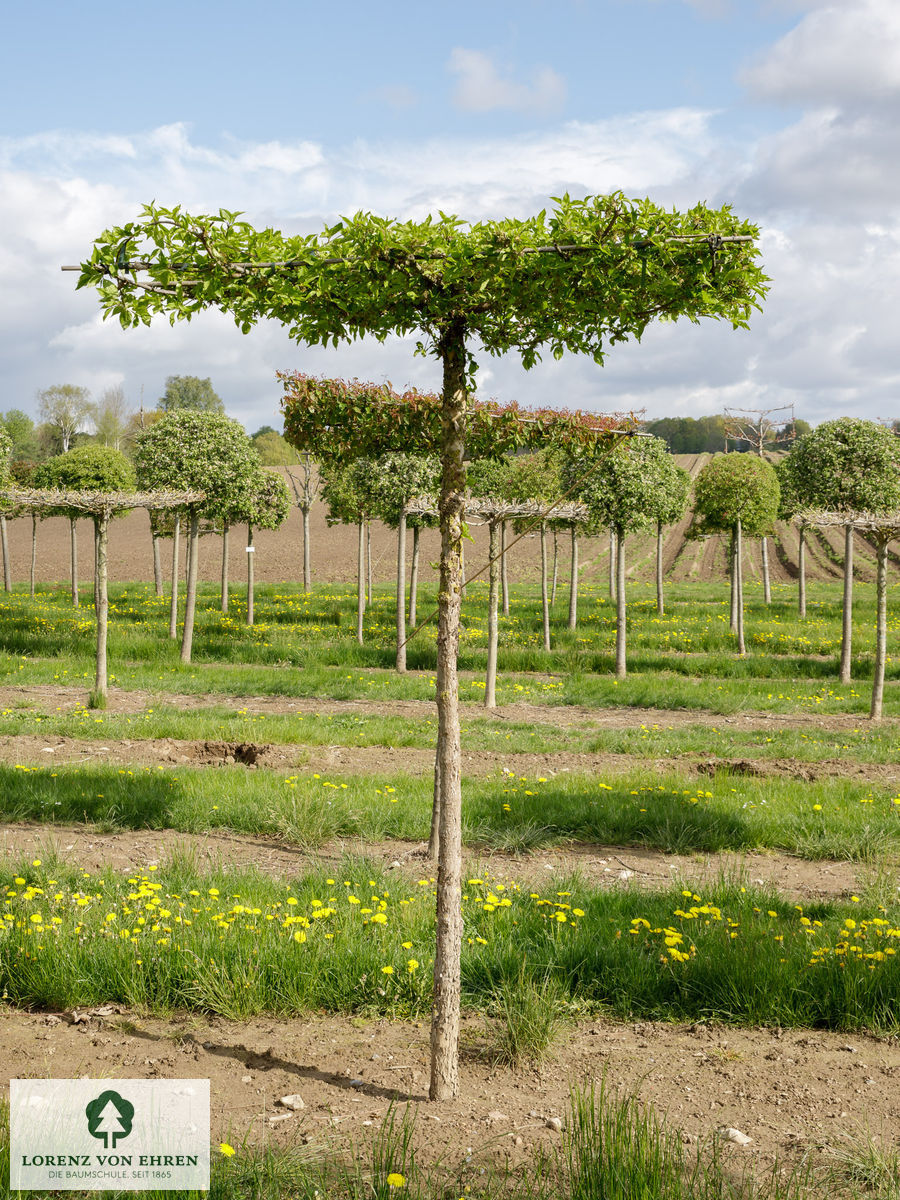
428,320,466,1100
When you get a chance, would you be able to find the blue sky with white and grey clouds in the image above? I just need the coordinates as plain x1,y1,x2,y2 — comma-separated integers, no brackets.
0,0,900,433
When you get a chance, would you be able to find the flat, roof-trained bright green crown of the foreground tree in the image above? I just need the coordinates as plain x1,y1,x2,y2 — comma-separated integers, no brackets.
78,192,767,367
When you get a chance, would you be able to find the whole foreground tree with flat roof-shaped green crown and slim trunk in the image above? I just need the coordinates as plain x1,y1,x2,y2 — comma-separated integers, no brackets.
78,193,767,1099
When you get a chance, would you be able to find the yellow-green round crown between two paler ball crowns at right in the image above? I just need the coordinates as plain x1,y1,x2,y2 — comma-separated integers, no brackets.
694,454,781,536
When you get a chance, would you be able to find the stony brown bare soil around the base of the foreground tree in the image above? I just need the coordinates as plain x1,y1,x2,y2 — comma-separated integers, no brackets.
0,1008,900,1182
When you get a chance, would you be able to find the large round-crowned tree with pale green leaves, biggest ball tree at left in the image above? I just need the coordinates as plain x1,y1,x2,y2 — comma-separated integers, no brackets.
134,409,259,662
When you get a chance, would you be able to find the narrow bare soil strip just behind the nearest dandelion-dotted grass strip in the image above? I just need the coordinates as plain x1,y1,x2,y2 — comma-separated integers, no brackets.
0,822,868,900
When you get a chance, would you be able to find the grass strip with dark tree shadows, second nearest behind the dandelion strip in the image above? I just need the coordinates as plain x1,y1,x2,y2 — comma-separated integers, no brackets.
0,758,900,863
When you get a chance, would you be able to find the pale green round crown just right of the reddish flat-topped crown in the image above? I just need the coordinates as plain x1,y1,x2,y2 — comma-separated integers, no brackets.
563,437,683,534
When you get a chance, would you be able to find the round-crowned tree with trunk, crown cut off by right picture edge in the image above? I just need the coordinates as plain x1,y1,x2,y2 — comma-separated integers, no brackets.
790,416,900,684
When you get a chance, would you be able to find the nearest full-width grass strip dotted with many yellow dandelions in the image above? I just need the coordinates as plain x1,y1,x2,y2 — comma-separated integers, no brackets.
0,859,900,1033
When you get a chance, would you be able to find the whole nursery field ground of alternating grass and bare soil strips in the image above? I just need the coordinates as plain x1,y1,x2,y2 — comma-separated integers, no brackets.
0,573,900,1200
